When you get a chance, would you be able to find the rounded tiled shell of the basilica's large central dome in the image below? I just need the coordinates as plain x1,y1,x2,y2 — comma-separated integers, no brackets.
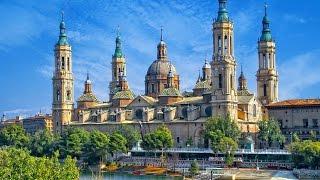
147,60,177,77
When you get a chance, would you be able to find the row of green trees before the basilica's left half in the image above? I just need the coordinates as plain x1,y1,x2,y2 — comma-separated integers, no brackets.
0,125,140,164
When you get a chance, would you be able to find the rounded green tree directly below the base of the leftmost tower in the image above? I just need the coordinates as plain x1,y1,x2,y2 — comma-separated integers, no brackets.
59,128,89,158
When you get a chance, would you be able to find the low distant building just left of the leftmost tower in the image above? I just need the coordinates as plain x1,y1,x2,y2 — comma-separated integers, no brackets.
22,114,53,134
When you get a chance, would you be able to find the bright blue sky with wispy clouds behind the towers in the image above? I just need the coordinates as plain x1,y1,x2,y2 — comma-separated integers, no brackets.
0,0,320,116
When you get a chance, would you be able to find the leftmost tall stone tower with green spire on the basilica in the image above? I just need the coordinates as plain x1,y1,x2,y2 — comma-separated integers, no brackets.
52,14,74,133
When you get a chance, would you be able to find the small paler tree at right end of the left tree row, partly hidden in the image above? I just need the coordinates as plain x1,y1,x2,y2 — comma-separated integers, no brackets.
118,125,141,150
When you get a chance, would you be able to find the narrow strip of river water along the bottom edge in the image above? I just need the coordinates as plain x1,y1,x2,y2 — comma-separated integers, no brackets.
80,173,182,180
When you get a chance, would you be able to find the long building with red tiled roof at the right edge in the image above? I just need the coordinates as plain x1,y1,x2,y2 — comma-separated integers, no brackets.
267,99,320,141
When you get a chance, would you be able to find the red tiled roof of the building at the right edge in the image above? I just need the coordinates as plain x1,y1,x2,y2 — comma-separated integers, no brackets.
267,99,320,108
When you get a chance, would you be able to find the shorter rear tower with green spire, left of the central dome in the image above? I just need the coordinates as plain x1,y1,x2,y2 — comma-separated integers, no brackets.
109,30,126,101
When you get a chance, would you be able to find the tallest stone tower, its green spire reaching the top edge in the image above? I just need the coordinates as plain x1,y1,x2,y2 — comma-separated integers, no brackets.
211,0,237,120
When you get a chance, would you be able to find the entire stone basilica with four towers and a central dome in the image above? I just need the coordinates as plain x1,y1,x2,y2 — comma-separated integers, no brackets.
52,0,278,147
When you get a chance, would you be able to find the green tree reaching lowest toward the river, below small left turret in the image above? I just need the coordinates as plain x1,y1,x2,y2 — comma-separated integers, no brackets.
85,130,110,164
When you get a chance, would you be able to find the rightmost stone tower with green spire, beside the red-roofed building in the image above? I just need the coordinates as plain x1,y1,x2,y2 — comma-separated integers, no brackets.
256,5,278,105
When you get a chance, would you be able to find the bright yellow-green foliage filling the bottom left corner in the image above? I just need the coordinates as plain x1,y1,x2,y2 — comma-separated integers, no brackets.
0,147,79,180
